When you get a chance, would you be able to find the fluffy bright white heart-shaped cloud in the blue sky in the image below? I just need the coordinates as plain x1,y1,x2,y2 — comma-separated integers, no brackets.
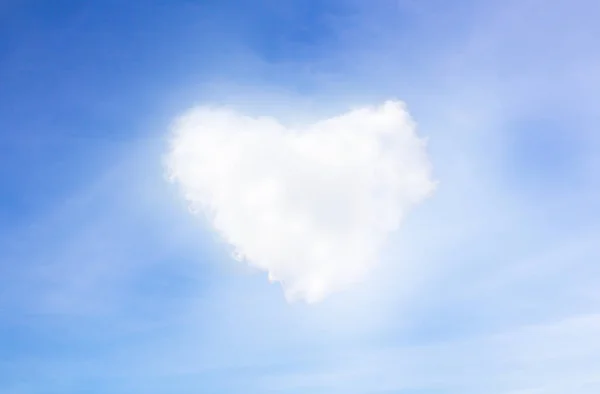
166,101,435,302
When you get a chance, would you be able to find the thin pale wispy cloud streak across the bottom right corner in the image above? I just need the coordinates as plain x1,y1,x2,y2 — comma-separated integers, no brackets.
263,315,600,394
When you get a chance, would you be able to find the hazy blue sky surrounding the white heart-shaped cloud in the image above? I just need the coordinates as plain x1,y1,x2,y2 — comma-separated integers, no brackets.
0,0,600,394
